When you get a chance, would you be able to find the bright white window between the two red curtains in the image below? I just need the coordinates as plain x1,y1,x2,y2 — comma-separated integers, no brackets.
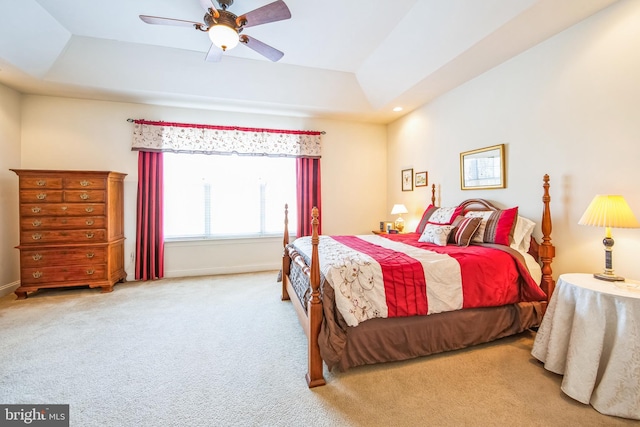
164,153,296,239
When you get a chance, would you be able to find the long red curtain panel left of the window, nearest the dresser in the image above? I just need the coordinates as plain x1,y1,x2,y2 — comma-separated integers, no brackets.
136,151,164,280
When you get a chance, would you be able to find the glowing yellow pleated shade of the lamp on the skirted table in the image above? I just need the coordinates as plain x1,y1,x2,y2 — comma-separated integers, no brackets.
578,195,640,228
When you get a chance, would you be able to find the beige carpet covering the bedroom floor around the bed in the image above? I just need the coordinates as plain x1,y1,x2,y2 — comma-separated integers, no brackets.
0,272,638,427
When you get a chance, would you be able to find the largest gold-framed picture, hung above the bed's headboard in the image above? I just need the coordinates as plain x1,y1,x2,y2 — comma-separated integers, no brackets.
460,144,506,190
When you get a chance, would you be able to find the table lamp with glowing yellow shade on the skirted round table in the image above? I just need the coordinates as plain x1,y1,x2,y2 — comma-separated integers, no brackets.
578,195,640,282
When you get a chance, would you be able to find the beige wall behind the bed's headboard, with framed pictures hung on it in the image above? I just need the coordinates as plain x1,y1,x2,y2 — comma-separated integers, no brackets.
387,0,640,279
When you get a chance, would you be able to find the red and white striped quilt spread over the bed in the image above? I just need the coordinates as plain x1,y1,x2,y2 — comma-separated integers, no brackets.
293,233,546,326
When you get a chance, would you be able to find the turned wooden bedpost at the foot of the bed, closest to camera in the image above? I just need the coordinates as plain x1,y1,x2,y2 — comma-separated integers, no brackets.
306,207,325,388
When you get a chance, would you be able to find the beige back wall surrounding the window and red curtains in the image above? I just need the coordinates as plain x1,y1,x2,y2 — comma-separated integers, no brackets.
13,95,387,280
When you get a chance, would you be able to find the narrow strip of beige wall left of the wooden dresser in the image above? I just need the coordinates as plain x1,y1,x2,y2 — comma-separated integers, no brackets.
0,85,20,295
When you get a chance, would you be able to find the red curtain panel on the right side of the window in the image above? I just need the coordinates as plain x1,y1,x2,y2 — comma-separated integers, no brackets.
296,157,322,237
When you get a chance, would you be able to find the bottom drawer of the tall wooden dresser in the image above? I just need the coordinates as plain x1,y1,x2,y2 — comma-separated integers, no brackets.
20,264,107,286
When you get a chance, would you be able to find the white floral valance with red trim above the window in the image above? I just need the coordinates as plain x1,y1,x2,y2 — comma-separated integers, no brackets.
131,120,322,158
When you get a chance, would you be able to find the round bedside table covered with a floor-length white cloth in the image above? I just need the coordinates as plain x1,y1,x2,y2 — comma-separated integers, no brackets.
531,274,640,420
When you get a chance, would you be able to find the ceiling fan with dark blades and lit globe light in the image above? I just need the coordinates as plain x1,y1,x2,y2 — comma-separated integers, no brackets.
140,0,291,62
